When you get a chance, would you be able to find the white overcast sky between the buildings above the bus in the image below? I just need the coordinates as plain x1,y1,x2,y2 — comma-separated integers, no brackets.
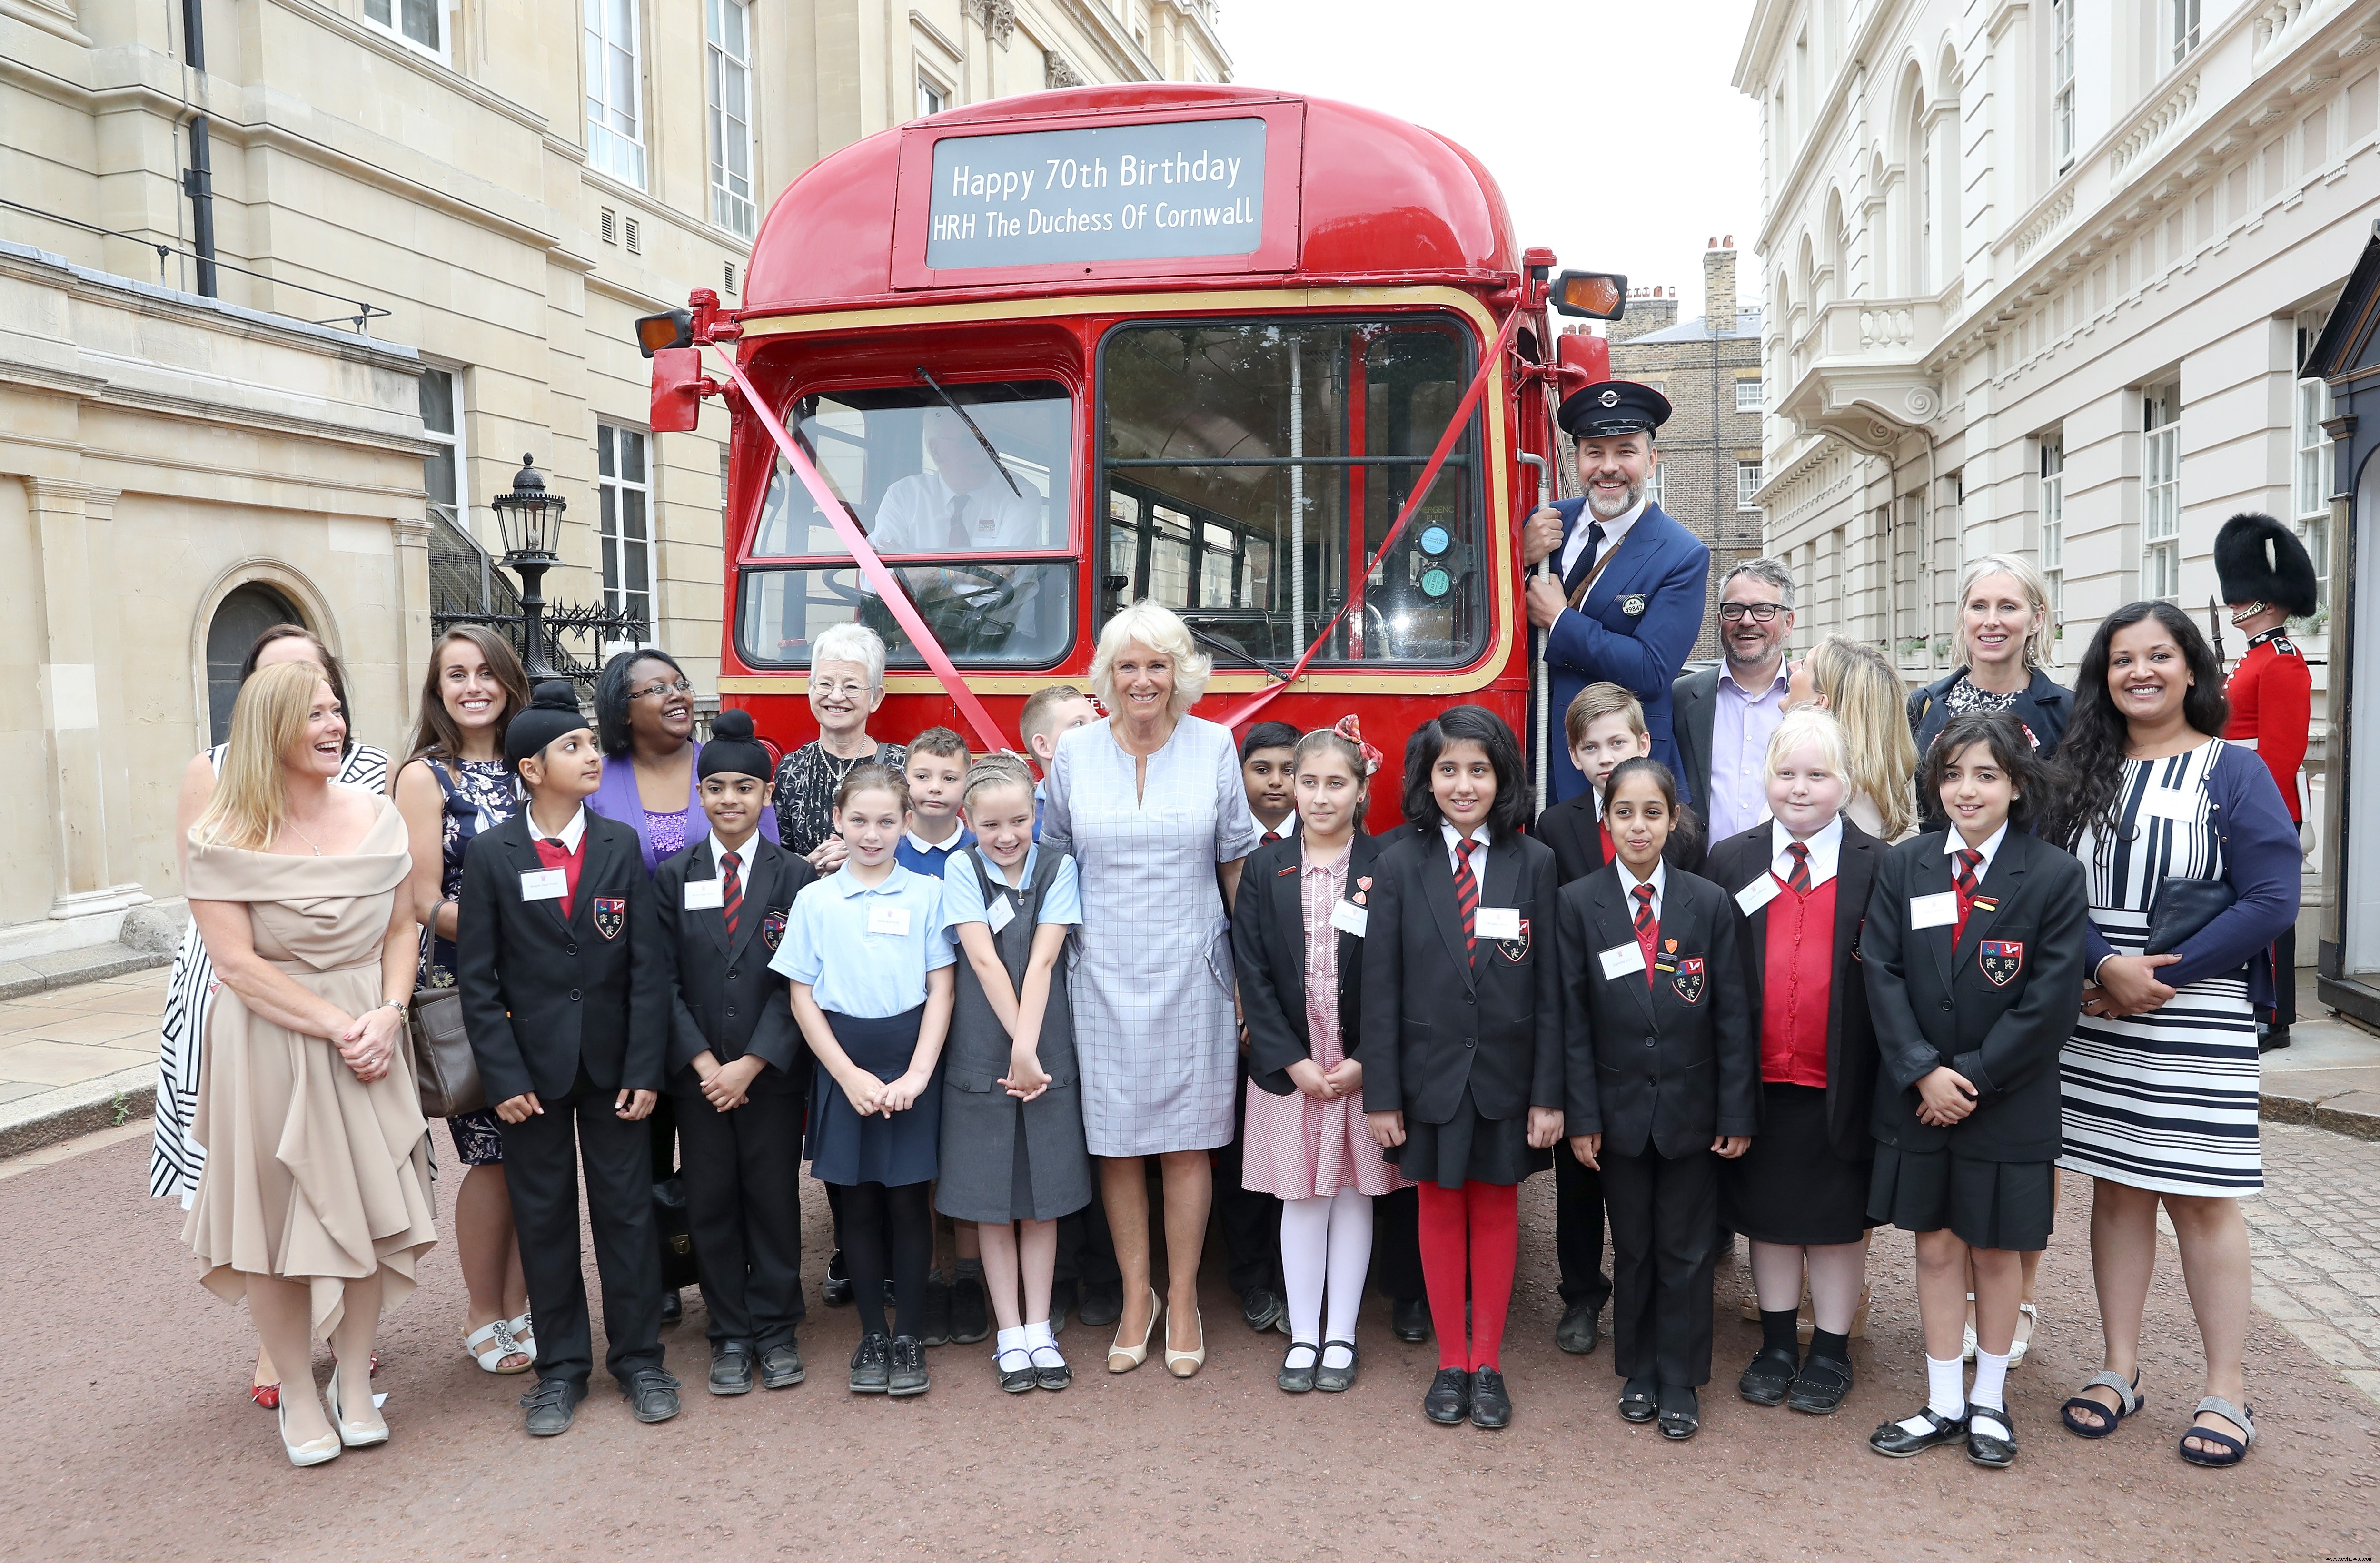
1221,0,1761,319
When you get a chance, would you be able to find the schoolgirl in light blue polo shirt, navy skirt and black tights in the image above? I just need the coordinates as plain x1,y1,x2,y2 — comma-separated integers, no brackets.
769,764,954,1394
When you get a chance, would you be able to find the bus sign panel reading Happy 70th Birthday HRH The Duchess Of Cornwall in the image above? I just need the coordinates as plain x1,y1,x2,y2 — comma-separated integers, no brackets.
926,119,1264,271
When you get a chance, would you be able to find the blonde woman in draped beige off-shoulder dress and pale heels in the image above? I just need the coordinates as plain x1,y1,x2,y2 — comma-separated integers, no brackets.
183,664,436,1465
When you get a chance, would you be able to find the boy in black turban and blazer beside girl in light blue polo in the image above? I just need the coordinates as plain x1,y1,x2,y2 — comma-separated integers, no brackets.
652,712,819,1394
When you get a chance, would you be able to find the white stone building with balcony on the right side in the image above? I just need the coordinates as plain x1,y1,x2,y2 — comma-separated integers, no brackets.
1735,0,2380,961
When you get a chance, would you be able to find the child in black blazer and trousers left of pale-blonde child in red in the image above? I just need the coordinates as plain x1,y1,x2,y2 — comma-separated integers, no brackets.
1557,762,1759,1437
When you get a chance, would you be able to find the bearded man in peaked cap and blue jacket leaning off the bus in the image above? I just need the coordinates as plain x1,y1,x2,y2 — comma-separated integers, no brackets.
1521,381,1711,804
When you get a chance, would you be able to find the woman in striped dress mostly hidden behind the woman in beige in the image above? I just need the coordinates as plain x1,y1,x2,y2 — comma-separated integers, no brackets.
150,623,388,1411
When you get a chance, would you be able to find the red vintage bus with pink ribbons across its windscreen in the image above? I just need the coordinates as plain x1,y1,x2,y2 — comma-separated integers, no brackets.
640,83,1626,823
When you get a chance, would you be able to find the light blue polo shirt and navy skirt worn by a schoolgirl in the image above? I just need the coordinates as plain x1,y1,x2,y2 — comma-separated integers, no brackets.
769,863,952,1187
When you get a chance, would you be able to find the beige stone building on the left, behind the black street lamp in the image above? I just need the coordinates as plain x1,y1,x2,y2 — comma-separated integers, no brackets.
0,0,1230,959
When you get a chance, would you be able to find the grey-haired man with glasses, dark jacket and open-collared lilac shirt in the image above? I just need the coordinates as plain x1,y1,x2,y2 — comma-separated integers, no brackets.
1671,559,1792,842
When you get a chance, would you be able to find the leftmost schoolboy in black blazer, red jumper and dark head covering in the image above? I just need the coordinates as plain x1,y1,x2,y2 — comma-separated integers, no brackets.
455,681,678,1437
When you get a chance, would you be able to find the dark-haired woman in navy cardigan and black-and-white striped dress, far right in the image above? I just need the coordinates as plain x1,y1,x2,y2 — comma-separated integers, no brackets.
2056,602,2299,1465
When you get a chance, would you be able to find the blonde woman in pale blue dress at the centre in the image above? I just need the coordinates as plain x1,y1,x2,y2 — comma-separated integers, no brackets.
1040,602,1261,1377
